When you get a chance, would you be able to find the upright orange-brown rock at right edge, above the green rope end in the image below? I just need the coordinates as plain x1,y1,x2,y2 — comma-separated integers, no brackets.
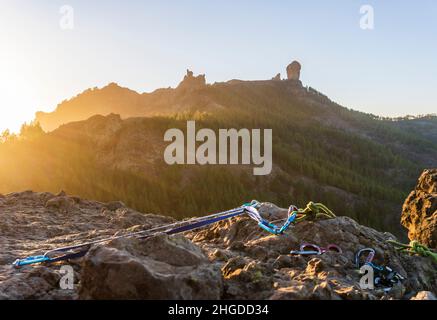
401,169,437,248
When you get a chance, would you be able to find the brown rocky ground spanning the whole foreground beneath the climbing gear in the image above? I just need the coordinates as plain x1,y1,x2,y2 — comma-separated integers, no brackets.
0,170,437,299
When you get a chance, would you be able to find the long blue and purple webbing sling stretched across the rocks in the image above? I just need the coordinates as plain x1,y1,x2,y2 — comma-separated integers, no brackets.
13,200,261,268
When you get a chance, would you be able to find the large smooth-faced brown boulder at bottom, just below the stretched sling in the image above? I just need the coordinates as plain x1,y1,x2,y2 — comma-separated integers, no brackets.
80,234,222,299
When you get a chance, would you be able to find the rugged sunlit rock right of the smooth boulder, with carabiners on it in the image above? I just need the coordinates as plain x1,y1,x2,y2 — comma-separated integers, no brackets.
191,205,437,299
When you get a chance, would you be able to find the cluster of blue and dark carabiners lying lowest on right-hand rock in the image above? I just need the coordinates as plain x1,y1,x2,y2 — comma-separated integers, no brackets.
355,248,405,291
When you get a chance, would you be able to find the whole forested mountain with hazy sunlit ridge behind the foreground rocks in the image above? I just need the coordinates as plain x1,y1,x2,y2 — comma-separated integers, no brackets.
0,67,437,238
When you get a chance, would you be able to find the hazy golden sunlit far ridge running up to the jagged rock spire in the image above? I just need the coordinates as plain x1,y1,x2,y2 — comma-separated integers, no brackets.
36,70,215,131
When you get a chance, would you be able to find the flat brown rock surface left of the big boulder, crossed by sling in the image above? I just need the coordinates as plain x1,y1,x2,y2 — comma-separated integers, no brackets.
0,191,173,299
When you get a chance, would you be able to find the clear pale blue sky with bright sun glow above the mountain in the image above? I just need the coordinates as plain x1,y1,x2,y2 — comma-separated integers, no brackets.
0,0,437,130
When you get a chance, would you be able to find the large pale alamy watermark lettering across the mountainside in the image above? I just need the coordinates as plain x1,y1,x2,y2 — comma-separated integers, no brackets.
164,121,272,175
